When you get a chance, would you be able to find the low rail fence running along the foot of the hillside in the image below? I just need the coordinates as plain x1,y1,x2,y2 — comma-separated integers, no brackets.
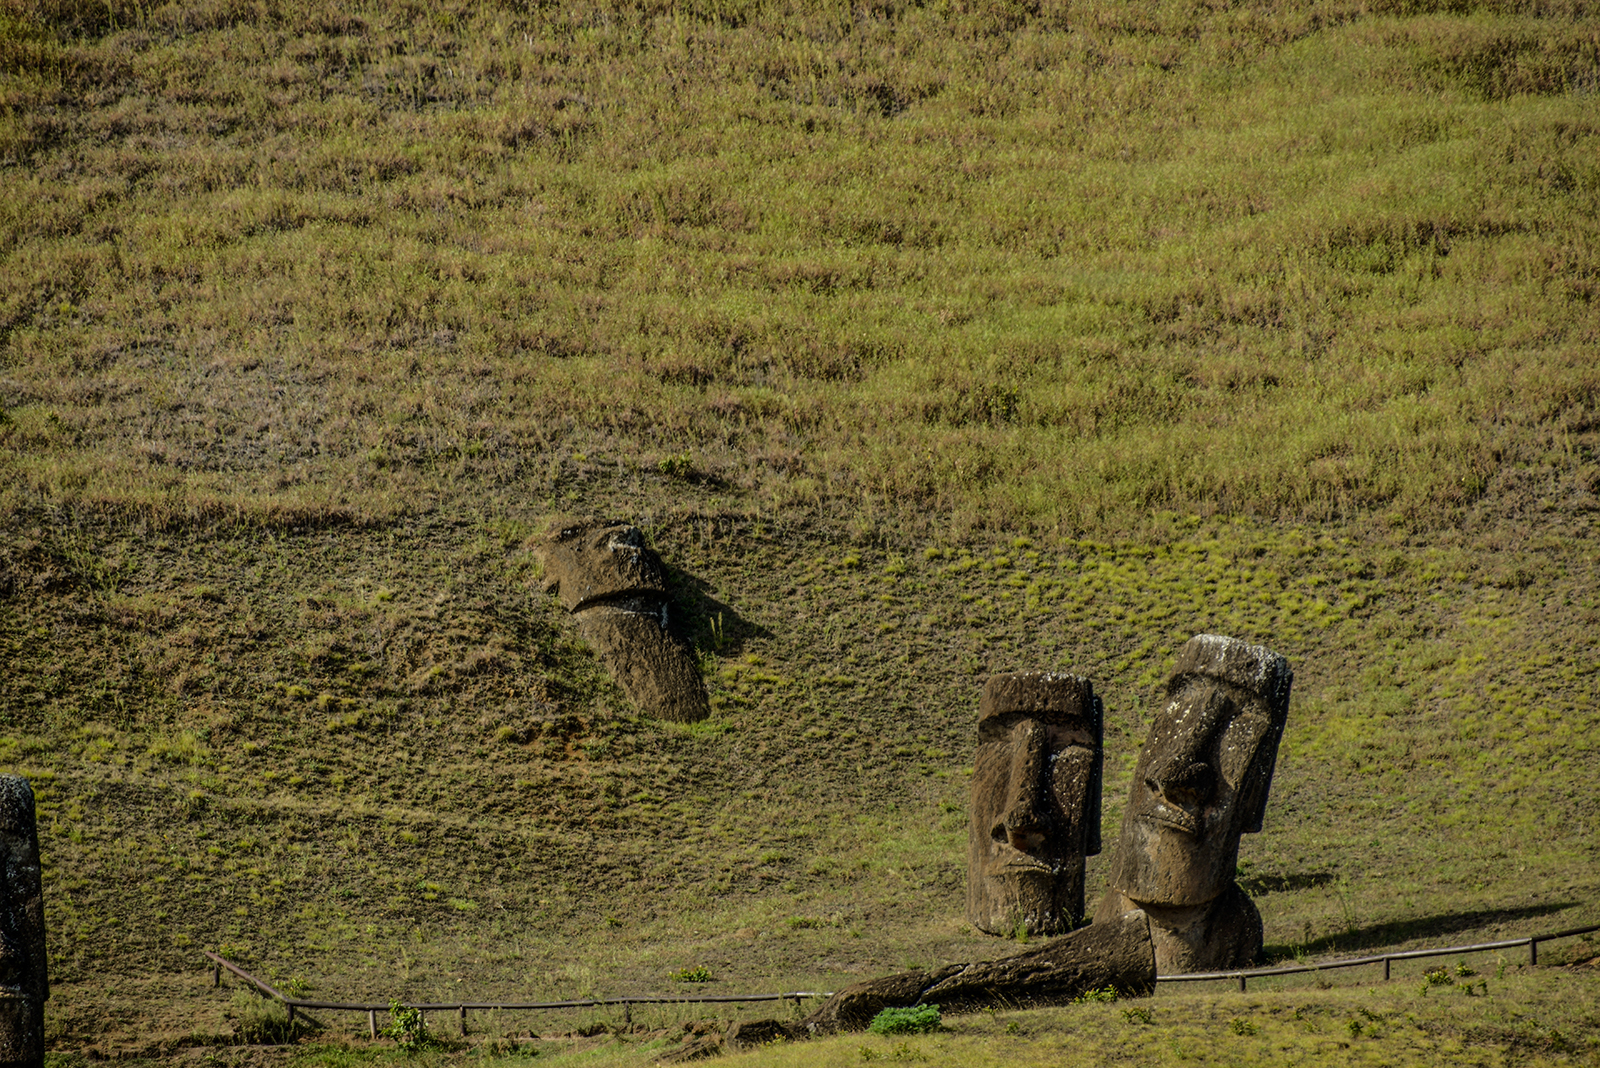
203,924,1600,1038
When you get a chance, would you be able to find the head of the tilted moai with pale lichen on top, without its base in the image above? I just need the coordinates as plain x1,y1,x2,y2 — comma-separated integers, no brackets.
1110,635,1294,905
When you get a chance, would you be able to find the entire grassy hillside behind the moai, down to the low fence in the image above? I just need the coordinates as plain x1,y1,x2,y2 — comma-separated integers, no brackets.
0,0,1600,1063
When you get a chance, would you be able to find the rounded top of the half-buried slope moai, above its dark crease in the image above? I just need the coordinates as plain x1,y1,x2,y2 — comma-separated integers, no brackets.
541,520,667,612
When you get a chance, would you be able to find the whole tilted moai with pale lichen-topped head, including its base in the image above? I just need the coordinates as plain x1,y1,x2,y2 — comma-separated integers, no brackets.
1094,635,1294,975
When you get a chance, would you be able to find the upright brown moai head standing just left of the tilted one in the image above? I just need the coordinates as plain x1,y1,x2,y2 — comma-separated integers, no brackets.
966,671,1104,935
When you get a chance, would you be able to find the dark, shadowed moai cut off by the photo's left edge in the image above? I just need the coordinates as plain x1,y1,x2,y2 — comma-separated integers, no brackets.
0,775,50,1068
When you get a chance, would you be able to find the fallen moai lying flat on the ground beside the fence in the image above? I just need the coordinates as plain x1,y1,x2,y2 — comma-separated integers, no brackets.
728,911,1155,1049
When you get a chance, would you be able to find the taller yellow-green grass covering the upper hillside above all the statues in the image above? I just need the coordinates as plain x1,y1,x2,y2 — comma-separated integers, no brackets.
0,2,1600,532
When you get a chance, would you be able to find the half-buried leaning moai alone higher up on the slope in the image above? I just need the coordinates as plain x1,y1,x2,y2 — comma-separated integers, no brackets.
539,521,710,723
